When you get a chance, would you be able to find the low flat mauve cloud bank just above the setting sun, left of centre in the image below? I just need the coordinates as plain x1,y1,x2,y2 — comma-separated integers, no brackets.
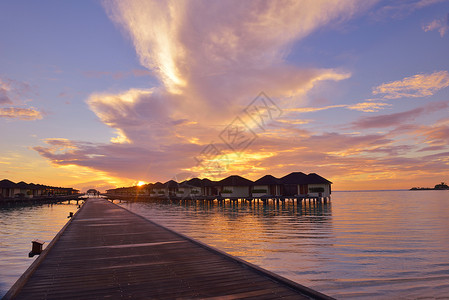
33,140,202,180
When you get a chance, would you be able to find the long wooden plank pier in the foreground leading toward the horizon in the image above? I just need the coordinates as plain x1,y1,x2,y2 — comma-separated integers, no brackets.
4,198,332,299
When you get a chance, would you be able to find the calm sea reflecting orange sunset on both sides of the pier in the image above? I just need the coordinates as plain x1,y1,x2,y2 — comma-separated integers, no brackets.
0,191,449,299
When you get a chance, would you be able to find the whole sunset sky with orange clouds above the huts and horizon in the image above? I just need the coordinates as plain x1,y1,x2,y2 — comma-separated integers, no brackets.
0,0,449,190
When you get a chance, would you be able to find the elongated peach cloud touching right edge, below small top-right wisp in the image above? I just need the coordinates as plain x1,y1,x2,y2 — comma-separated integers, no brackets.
373,71,449,99
